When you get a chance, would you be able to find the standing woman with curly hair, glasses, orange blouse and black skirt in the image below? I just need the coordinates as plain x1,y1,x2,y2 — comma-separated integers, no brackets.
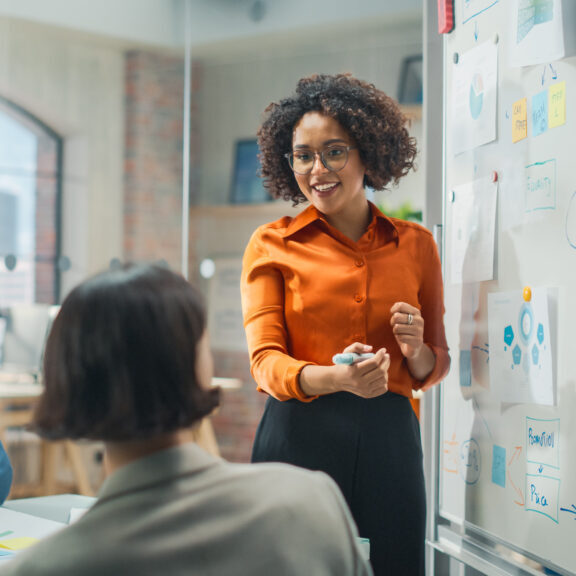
242,74,450,576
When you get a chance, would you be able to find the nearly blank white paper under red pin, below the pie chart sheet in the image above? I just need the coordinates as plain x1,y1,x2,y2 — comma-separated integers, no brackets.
449,178,498,284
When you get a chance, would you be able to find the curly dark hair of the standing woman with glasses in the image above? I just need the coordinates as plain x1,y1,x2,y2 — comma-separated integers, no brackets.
258,74,416,206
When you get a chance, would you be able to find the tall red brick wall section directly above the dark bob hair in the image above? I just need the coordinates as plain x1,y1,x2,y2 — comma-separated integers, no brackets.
124,51,184,268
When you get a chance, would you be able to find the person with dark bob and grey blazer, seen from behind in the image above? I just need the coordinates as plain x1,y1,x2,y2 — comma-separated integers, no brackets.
2,265,372,576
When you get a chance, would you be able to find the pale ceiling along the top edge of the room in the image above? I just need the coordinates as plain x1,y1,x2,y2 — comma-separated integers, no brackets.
0,0,422,48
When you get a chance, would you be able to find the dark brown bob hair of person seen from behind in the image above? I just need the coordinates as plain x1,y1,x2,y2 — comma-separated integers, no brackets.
34,265,220,441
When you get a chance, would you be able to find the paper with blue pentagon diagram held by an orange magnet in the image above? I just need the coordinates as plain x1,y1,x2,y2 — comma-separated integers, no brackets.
488,288,555,406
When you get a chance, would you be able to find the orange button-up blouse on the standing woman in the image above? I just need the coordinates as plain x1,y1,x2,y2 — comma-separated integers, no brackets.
241,204,450,402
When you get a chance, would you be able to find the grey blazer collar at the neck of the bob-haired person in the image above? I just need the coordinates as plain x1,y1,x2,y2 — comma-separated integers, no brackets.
95,442,223,506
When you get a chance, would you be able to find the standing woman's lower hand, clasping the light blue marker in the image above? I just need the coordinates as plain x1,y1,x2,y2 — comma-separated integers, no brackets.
336,342,390,398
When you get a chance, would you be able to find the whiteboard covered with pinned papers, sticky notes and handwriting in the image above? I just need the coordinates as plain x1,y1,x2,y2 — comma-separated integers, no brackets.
439,0,576,574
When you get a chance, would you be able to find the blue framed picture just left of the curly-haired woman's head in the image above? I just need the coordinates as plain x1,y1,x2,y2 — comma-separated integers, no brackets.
230,138,272,204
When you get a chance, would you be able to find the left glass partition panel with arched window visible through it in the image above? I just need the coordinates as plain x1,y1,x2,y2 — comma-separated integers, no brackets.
0,6,186,497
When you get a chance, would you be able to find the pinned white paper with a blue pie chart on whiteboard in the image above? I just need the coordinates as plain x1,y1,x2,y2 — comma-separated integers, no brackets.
451,41,498,155
